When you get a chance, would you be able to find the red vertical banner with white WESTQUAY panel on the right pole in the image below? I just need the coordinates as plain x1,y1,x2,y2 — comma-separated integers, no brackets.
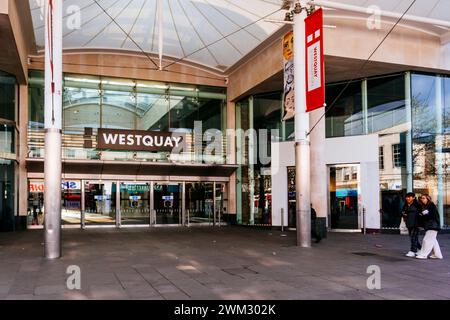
305,8,325,112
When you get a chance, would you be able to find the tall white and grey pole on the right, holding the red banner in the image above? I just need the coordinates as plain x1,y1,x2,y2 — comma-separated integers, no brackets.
294,6,311,248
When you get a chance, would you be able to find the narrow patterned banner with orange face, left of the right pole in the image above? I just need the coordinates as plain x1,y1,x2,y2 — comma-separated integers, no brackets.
283,31,295,121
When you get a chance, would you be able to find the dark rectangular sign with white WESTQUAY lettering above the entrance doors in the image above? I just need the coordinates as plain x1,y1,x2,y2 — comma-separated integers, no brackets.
97,129,186,152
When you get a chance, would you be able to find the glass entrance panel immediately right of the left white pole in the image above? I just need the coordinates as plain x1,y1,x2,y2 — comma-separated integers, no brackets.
62,180,81,225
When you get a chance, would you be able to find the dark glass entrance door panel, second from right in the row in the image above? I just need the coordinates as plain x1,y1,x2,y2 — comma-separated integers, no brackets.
186,182,214,224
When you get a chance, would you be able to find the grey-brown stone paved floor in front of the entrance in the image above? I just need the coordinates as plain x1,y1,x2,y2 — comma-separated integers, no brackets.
0,227,450,300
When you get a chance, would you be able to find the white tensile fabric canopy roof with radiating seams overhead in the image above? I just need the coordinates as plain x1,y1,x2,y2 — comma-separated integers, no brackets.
29,0,450,71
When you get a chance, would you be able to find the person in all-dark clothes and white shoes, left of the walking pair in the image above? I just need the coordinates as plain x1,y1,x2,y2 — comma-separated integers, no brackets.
402,192,422,258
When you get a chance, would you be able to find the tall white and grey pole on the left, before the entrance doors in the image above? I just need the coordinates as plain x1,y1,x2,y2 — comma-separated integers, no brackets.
44,0,63,259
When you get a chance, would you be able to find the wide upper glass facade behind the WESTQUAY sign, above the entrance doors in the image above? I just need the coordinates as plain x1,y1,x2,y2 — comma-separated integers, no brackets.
29,71,226,163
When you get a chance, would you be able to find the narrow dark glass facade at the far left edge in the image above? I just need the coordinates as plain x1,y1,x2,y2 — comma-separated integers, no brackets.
0,71,17,232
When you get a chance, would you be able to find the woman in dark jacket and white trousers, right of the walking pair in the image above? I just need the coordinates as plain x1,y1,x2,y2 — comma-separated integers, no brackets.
416,194,443,259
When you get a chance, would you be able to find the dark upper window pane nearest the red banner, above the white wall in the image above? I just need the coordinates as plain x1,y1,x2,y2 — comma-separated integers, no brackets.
326,81,364,138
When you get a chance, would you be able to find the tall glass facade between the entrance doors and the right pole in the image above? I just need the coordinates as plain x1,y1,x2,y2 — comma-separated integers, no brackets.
236,92,284,225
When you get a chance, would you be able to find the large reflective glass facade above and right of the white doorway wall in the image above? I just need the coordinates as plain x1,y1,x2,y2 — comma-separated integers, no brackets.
326,72,450,228
